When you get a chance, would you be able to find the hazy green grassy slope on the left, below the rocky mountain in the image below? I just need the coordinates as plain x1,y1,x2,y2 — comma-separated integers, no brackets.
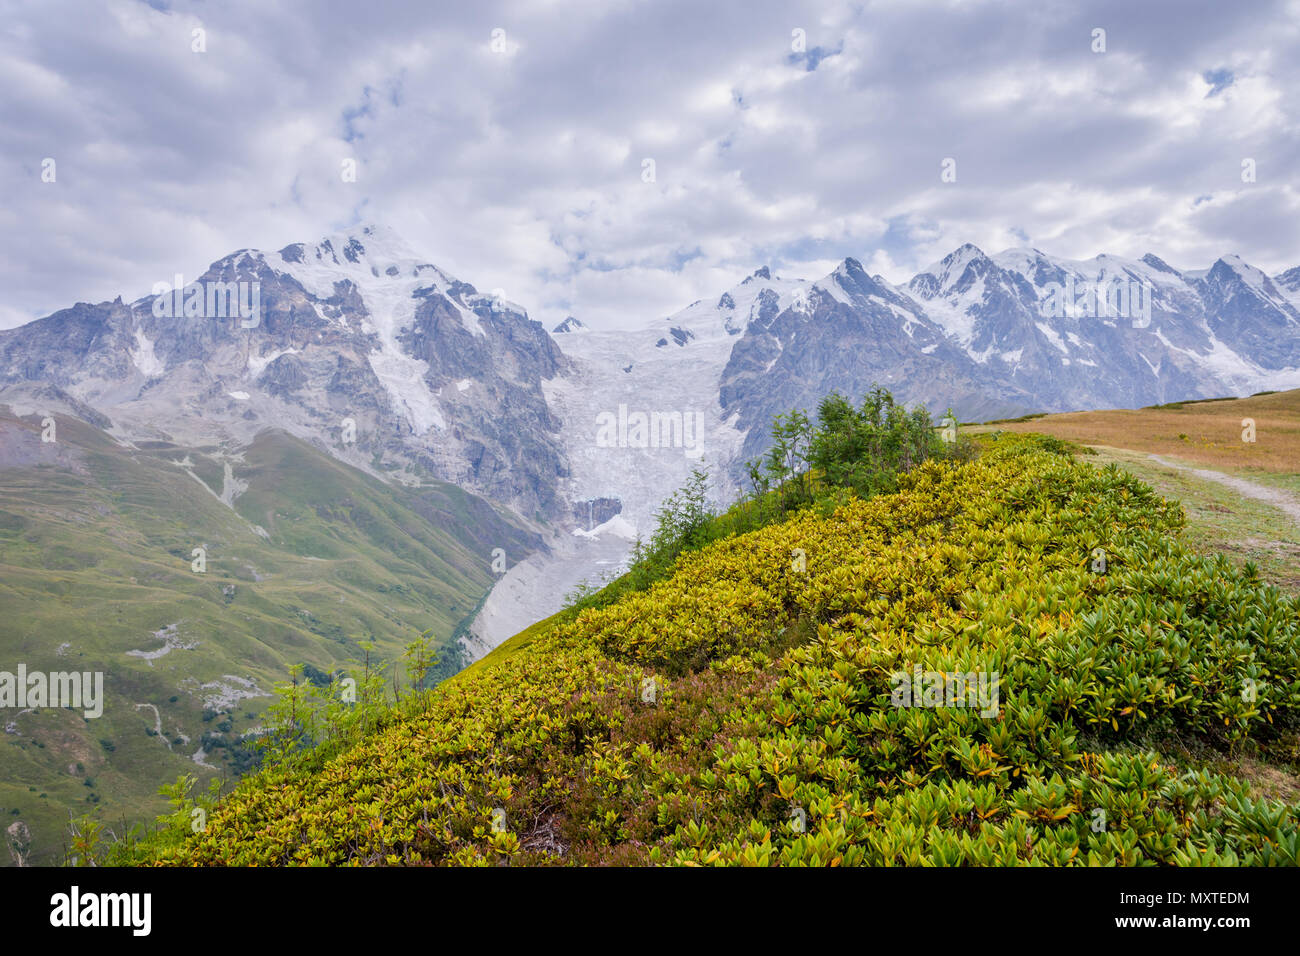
0,418,533,862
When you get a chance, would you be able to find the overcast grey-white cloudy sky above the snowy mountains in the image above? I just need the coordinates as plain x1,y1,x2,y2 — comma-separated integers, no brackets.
0,0,1300,328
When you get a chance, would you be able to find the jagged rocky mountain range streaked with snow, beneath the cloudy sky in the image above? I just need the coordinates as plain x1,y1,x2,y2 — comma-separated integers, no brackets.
0,226,1300,541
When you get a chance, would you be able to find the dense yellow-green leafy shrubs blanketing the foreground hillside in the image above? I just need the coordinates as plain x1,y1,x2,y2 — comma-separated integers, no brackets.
137,437,1300,865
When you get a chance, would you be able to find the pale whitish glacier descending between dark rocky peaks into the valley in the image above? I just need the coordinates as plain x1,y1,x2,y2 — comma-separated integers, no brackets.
465,271,811,658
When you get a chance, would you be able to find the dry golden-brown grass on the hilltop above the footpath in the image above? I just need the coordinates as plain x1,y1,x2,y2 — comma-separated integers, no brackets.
972,389,1300,475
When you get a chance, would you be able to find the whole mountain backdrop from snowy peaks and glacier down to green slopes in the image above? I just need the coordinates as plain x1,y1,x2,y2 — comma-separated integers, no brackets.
0,226,1300,861
